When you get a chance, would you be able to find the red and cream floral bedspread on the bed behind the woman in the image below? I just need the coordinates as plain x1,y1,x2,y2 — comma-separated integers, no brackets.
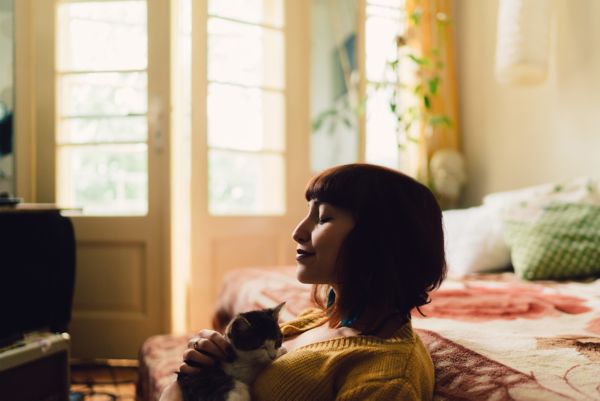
138,268,600,401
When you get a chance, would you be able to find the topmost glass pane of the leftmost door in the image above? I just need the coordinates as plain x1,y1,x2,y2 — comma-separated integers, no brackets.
57,1,148,71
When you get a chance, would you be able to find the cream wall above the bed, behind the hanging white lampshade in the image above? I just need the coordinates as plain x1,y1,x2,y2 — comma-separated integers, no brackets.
455,0,600,205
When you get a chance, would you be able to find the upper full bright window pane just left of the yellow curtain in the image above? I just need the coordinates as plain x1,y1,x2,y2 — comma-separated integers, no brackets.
365,12,403,82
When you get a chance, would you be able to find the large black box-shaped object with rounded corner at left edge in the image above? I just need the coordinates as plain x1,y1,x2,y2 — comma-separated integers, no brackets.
0,207,75,347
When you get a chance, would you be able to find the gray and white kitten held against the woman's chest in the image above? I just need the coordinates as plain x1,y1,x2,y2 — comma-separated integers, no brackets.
177,302,285,401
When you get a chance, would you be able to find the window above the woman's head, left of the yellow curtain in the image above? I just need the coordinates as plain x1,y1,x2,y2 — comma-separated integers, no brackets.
311,0,407,171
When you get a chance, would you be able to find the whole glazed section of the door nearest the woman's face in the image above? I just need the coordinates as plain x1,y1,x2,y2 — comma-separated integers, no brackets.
207,0,286,215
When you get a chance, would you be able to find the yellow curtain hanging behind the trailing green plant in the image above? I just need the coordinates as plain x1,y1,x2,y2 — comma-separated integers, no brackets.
406,0,460,188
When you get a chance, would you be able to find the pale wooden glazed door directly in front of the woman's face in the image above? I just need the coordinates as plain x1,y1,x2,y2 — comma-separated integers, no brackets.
189,0,310,330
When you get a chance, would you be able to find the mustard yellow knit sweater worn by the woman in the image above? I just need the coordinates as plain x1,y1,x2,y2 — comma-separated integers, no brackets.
252,310,434,401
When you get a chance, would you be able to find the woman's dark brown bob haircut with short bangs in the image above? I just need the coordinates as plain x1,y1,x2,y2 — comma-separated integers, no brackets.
305,164,446,332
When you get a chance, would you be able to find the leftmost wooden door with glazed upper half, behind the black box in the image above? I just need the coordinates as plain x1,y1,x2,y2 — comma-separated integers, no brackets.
30,0,169,358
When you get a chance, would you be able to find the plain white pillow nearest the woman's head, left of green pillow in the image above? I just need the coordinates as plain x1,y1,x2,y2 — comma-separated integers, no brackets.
443,206,510,277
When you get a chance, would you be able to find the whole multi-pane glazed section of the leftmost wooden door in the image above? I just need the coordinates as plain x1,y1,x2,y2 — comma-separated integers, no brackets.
56,0,148,215
